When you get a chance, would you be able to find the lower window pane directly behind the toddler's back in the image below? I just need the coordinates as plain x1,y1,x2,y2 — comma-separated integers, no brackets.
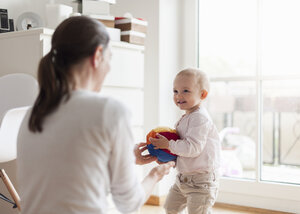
207,81,257,179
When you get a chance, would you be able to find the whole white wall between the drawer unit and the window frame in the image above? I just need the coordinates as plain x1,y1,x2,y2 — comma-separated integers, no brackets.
111,0,184,196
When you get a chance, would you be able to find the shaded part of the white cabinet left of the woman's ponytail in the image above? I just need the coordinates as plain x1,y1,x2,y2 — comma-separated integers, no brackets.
0,28,53,77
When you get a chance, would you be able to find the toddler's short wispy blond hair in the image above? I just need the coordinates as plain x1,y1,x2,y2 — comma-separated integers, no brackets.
176,68,209,92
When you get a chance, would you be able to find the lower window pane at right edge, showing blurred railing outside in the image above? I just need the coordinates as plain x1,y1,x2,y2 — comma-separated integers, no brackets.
262,80,300,183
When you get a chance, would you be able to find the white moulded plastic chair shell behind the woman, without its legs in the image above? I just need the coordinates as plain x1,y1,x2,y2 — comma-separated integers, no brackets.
0,73,38,160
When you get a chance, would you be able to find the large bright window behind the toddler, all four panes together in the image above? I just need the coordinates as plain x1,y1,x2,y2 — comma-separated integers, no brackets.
199,0,300,185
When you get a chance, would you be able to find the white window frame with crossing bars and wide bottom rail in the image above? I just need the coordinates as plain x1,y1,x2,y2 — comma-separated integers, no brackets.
182,0,300,213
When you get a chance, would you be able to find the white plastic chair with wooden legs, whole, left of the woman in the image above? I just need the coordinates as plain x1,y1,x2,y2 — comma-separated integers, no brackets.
0,73,38,214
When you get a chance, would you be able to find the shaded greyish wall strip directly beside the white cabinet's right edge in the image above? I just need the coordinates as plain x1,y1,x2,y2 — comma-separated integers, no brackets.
111,0,159,133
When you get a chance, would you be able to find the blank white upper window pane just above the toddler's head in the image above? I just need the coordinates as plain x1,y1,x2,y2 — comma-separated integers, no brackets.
199,0,257,77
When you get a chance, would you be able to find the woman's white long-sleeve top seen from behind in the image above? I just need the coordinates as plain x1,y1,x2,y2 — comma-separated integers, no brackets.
17,91,145,214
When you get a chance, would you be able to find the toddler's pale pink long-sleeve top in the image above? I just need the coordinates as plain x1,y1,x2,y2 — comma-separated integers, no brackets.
169,106,221,174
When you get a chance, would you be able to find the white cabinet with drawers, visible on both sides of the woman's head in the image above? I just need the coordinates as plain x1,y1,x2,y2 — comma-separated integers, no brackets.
0,28,144,141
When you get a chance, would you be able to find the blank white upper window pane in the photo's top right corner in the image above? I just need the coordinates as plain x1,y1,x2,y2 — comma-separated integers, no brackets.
262,0,300,75
